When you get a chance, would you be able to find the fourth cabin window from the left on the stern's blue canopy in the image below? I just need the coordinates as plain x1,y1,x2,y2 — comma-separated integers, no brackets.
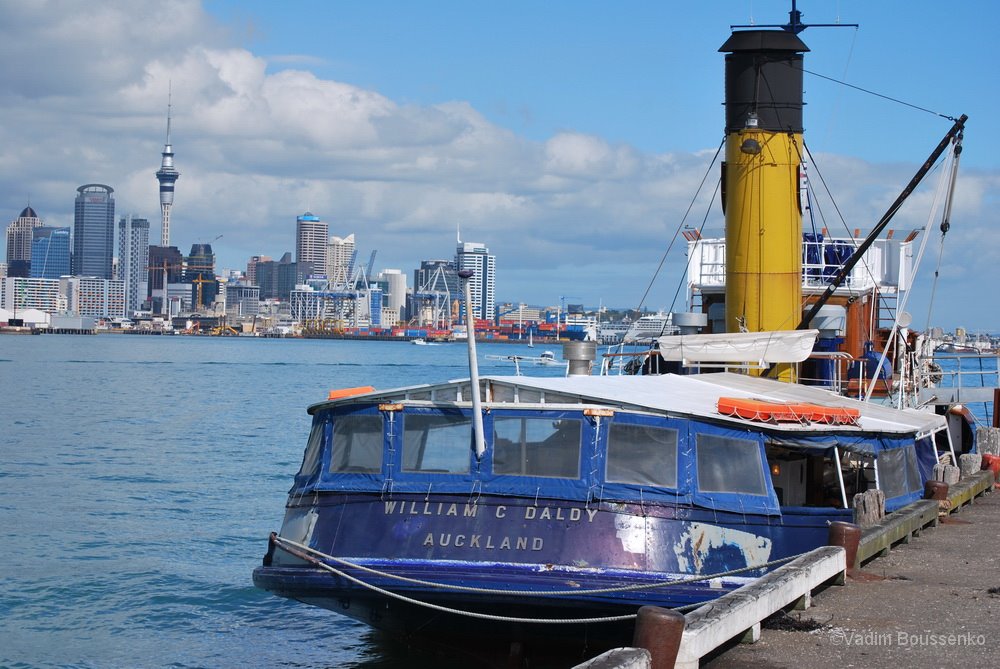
605,423,677,488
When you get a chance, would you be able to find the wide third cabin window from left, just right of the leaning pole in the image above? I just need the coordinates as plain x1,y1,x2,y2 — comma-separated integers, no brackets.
493,416,582,479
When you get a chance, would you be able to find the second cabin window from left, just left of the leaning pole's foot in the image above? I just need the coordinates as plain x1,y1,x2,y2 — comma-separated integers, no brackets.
403,414,472,474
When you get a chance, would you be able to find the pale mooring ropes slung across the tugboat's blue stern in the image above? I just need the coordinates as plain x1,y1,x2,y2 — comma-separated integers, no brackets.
273,535,805,624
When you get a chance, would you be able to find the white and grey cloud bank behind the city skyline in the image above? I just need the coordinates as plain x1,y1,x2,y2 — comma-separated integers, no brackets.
0,0,1000,328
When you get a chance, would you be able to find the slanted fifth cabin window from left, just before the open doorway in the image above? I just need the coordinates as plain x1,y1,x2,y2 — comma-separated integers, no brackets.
697,434,767,495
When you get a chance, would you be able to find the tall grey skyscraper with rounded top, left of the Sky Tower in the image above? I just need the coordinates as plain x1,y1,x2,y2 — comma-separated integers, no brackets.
73,184,115,279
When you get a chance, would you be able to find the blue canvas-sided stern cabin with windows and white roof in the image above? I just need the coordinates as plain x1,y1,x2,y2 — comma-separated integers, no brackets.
291,373,945,519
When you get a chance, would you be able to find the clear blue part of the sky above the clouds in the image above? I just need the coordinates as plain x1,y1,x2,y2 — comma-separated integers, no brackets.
206,0,1000,166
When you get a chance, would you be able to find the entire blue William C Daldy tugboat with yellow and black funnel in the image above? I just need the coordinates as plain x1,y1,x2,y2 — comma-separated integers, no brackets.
254,4,984,650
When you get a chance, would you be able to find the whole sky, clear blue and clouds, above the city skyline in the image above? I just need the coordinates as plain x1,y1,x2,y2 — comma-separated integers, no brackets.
0,0,1000,332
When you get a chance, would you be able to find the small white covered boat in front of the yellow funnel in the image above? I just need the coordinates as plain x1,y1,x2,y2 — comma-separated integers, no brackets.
656,330,819,363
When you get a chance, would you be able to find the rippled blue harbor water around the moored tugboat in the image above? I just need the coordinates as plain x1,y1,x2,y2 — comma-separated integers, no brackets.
0,335,996,669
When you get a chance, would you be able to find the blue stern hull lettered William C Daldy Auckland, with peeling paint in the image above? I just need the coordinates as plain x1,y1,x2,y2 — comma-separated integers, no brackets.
254,493,845,644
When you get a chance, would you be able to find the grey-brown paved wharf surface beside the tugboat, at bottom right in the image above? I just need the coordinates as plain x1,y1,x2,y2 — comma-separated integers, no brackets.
702,486,1000,669
